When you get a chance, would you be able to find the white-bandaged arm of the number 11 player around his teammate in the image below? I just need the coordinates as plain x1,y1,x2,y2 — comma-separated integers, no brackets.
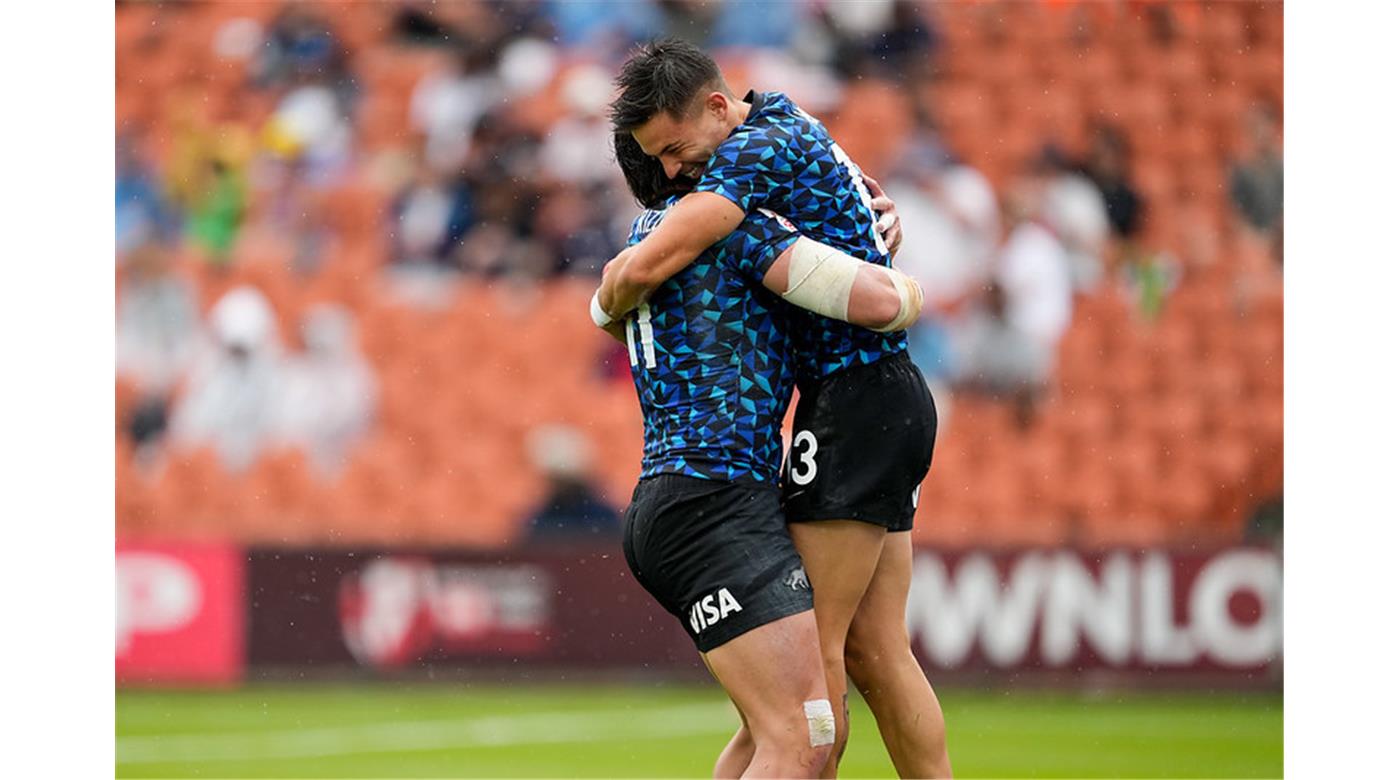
763,237,924,333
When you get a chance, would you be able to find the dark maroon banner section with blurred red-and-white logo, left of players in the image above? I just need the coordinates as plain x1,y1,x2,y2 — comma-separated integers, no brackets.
248,546,699,671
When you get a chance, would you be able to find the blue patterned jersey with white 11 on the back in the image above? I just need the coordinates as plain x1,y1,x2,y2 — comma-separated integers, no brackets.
626,199,798,483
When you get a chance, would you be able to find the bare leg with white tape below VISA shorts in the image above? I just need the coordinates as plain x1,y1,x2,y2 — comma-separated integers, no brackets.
706,611,836,777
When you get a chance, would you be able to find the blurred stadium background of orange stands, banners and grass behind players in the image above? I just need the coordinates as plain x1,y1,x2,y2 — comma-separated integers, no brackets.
115,0,1284,777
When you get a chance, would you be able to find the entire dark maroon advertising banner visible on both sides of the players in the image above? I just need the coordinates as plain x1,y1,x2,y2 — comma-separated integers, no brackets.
248,545,1282,685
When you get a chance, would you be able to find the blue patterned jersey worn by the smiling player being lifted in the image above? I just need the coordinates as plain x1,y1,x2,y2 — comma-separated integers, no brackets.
696,92,907,381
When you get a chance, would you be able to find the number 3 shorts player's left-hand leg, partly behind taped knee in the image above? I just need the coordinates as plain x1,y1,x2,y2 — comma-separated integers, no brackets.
788,520,886,777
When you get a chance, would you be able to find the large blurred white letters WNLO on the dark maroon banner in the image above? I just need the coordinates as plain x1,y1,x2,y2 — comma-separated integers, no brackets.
907,549,1282,668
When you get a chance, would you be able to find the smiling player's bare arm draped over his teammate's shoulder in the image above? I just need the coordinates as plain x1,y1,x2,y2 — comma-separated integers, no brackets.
598,192,743,319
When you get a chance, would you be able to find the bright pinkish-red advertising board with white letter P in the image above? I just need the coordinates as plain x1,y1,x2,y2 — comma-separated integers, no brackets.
116,545,245,683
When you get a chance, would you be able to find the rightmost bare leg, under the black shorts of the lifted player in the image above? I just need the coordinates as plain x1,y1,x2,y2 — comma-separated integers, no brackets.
846,531,952,777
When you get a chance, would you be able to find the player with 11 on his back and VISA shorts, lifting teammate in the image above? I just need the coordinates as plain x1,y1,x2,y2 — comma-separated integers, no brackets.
606,133,921,777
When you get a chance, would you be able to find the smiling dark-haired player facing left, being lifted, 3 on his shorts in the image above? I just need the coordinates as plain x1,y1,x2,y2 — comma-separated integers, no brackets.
594,41,951,777
